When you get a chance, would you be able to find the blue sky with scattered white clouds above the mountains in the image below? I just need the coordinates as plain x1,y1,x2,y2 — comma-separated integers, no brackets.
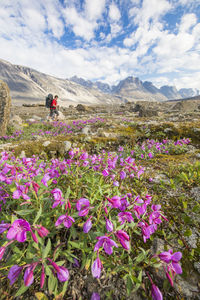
0,0,200,90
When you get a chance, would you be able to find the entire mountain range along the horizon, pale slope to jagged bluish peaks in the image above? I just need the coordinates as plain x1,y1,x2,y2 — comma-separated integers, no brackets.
0,59,200,106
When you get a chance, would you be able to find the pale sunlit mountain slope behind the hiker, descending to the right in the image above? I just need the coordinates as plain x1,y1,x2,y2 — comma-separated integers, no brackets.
0,60,119,106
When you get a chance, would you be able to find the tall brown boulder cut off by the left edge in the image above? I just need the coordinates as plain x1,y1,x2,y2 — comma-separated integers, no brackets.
0,80,11,136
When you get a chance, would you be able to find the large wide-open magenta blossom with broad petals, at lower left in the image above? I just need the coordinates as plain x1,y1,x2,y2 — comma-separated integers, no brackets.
7,219,31,243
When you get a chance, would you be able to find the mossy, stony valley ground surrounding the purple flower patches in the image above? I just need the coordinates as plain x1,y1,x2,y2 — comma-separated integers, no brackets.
0,101,200,300
